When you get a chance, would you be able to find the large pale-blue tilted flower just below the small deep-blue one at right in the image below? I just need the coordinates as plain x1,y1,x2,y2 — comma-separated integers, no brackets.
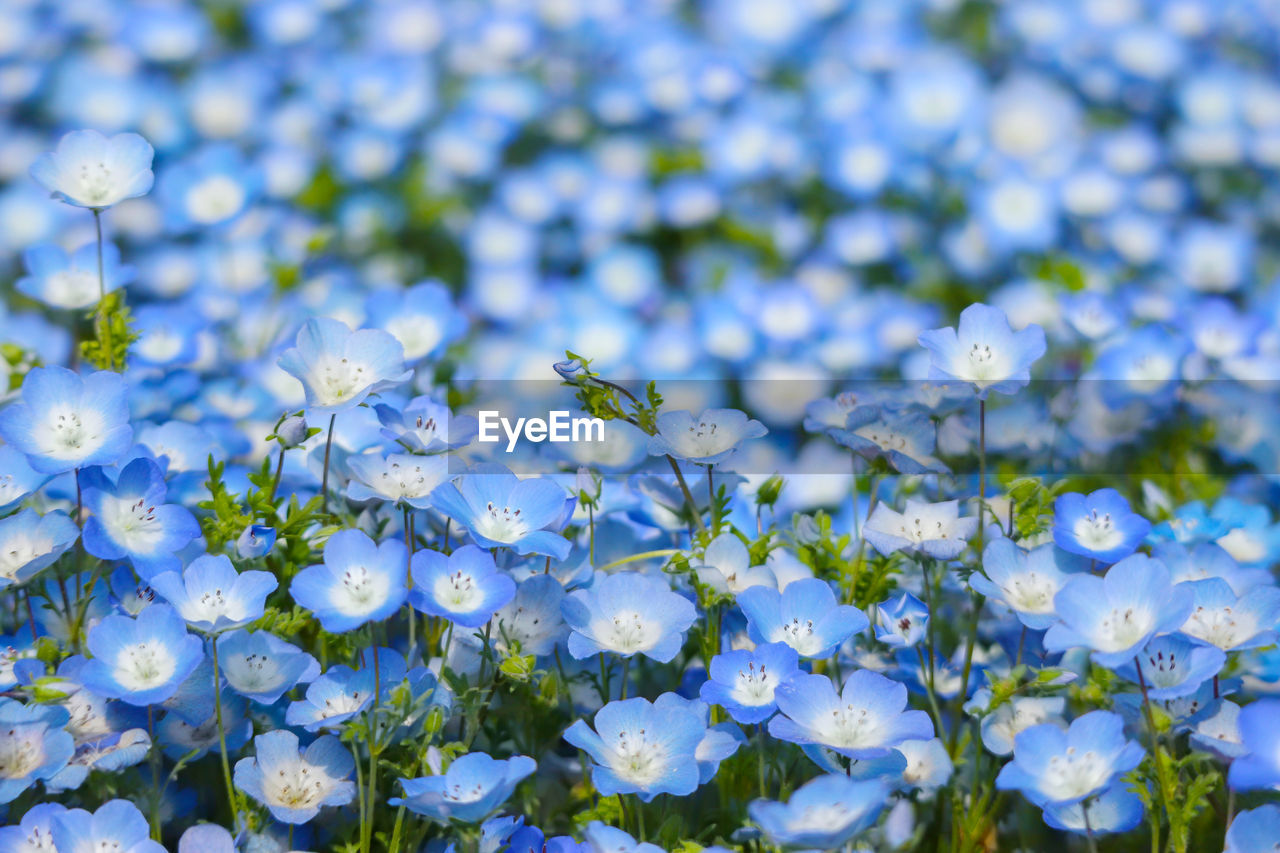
1044,553,1193,667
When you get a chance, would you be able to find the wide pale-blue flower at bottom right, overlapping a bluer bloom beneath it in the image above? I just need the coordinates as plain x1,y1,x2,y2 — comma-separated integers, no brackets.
996,711,1143,807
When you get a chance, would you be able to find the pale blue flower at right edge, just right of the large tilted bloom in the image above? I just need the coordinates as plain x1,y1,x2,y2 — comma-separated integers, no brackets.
1181,578,1280,652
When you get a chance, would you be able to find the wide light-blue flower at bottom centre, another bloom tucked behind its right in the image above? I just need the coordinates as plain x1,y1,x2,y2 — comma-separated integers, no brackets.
564,693,707,802
